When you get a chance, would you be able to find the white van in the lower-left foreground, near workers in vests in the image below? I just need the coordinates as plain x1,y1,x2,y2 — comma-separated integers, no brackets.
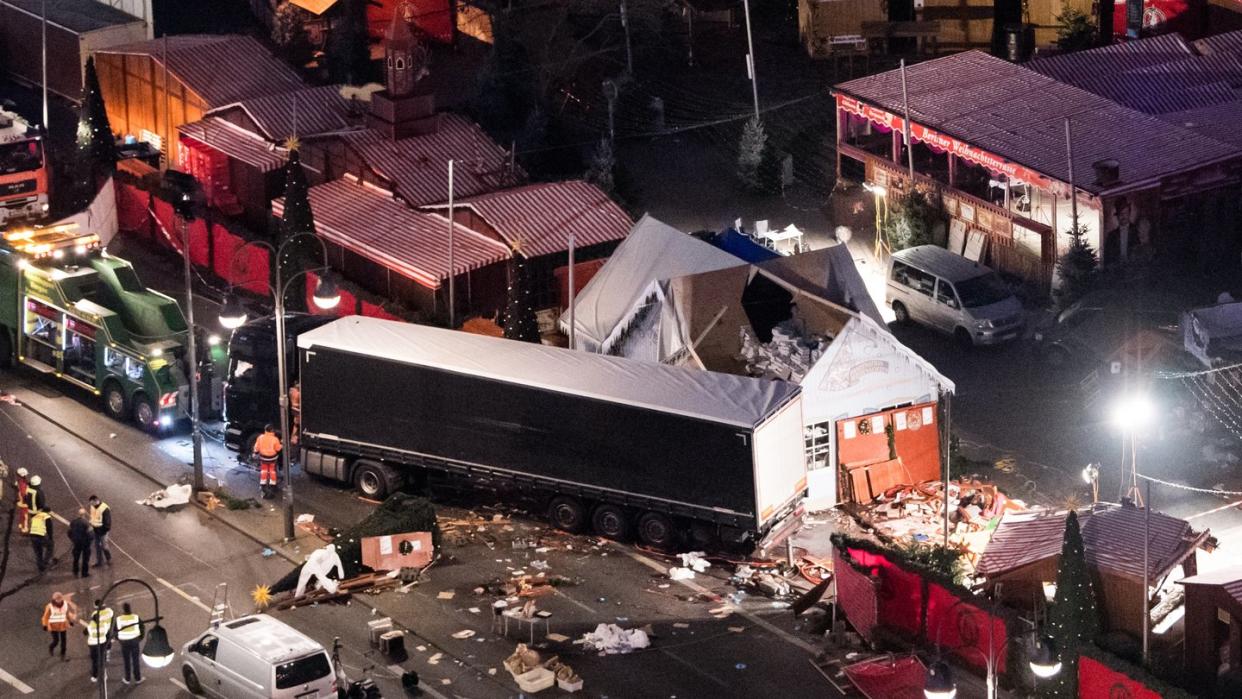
181,615,337,699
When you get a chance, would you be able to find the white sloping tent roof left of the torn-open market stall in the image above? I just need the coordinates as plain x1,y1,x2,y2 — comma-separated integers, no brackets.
560,214,741,351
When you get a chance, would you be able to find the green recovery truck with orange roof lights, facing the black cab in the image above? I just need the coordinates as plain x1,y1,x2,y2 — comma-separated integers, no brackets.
0,225,227,432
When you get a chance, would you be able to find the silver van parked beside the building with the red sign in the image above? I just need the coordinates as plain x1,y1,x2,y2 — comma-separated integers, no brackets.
884,245,1023,346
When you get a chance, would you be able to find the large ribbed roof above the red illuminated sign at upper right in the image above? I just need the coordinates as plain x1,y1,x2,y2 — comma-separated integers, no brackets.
835,51,1242,195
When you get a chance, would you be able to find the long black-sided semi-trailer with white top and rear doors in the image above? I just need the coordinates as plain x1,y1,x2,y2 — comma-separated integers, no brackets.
297,317,806,548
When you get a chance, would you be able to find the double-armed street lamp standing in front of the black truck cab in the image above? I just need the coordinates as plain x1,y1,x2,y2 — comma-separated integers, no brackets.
220,232,340,541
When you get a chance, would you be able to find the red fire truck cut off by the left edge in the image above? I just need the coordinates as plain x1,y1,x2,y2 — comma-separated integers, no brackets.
0,107,48,225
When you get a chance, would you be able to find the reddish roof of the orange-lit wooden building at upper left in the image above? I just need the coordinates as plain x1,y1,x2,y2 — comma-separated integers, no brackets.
97,34,306,109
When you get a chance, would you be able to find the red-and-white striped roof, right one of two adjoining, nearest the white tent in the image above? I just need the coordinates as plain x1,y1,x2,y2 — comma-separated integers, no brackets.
424,180,633,257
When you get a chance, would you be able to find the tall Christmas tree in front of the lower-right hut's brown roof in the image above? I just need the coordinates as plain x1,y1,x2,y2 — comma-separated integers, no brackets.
1040,510,1099,699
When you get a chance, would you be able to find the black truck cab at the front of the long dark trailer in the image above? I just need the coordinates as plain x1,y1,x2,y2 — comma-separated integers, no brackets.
224,314,334,459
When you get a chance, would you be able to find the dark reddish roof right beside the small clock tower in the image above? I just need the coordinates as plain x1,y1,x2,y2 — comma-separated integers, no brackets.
342,113,525,206
